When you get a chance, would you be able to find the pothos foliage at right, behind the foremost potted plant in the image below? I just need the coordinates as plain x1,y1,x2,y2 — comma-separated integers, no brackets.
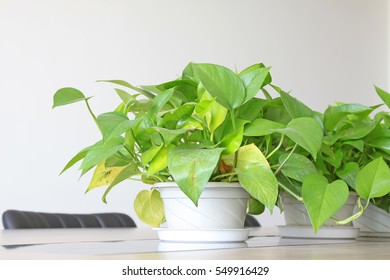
256,87,390,231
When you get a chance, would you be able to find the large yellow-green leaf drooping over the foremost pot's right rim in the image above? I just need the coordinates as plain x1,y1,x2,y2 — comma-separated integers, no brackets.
235,163,278,213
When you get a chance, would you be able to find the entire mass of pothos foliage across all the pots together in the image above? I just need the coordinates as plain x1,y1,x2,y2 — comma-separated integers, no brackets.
53,63,390,230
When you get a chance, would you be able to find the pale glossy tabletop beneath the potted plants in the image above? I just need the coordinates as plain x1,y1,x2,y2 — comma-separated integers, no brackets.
0,228,390,260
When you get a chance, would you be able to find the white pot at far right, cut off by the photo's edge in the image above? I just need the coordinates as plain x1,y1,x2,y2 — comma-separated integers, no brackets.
353,204,390,233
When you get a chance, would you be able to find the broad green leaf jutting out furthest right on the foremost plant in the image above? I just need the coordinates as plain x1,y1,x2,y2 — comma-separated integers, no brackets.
274,118,323,159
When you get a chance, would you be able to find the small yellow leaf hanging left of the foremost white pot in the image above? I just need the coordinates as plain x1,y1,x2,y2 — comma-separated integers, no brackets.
134,189,165,227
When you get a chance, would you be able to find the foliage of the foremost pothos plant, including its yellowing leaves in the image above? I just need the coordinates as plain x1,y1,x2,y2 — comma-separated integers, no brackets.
53,63,323,226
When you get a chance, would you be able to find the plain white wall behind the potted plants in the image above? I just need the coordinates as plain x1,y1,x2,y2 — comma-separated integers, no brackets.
0,0,390,229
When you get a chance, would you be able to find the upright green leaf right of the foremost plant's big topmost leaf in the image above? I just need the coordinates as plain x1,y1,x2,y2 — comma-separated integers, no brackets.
239,67,271,103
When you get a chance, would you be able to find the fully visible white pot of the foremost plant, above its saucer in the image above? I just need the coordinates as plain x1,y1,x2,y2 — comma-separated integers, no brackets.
155,182,249,229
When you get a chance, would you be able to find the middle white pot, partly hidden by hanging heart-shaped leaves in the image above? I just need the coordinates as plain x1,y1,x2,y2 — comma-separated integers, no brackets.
280,193,357,226
